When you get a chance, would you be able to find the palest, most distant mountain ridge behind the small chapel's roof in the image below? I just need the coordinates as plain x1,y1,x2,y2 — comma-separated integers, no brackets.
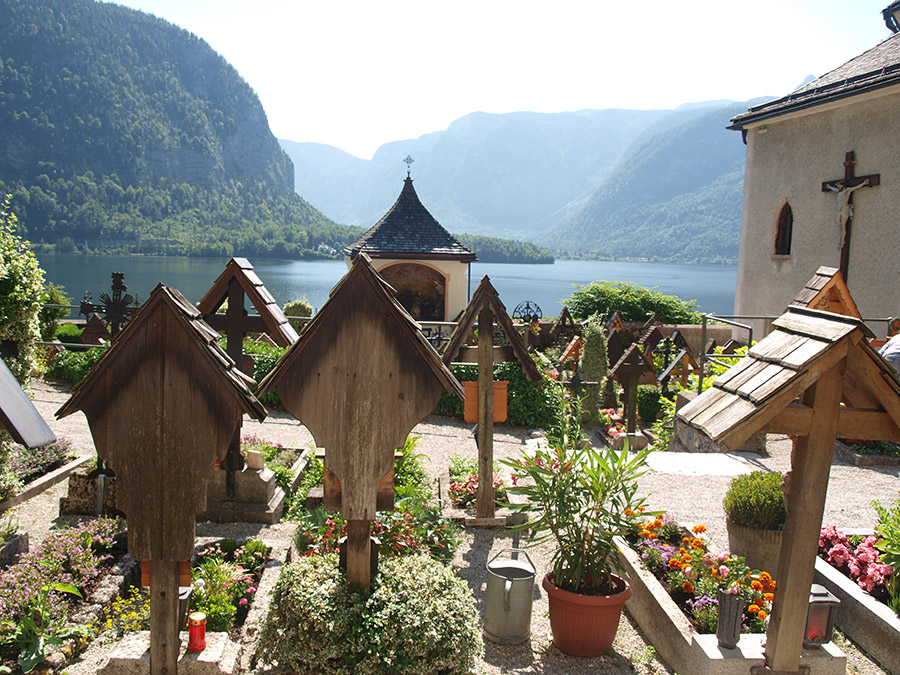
280,110,671,239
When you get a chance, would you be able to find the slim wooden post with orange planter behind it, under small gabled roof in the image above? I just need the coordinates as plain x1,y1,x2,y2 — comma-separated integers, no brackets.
475,306,494,518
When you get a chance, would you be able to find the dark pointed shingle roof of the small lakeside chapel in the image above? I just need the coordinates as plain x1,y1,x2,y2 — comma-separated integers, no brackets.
344,178,477,262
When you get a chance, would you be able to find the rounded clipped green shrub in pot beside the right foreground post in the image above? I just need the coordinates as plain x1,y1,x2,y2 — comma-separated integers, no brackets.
722,471,787,530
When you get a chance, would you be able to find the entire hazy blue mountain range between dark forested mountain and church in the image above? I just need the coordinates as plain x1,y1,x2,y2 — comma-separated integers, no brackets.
280,101,749,262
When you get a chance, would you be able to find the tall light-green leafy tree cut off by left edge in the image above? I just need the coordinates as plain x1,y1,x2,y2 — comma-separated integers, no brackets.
0,195,44,387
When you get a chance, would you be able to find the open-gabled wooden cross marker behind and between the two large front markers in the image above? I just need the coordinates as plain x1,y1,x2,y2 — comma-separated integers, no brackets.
197,258,299,508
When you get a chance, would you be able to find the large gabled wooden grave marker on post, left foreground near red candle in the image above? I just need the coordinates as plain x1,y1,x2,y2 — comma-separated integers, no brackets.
56,284,266,675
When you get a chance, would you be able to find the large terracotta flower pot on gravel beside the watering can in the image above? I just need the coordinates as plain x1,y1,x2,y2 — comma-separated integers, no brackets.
541,574,631,656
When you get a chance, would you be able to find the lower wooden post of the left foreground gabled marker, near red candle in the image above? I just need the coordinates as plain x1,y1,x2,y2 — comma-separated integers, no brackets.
150,560,179,675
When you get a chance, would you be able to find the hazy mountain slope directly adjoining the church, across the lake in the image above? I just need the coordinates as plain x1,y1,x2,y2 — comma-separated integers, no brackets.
535,103,749,262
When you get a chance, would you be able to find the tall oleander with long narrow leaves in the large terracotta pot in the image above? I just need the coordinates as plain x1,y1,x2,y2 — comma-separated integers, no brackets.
503,401,652,595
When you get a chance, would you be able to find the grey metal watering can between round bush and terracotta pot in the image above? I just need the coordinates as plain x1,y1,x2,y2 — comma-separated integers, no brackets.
484,548,534,645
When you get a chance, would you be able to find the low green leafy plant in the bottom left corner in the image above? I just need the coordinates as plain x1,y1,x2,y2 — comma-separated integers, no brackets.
0,582,86,673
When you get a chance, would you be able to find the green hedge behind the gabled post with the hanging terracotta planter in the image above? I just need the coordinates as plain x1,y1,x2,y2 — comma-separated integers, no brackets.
435,361,562,429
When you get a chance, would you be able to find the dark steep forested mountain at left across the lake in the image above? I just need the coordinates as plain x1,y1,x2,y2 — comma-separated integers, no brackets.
0,0,359,256
